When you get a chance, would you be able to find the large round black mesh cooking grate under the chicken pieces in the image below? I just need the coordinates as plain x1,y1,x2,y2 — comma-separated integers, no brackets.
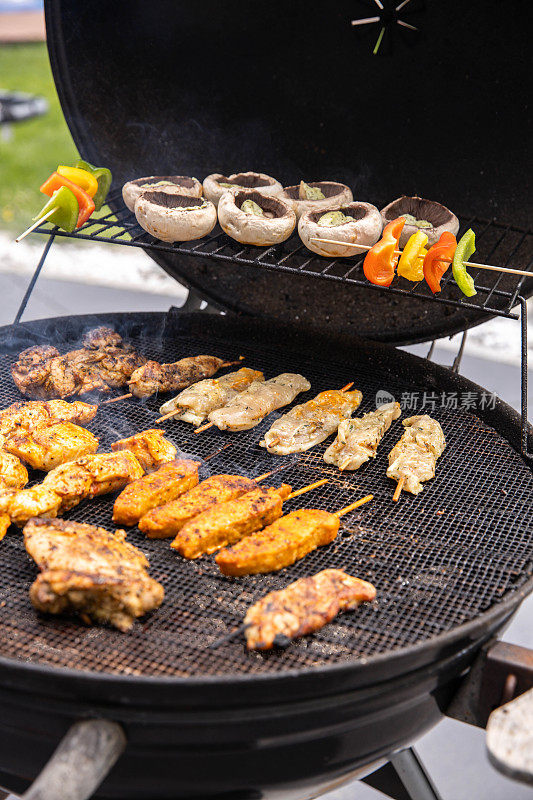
0,318,533,676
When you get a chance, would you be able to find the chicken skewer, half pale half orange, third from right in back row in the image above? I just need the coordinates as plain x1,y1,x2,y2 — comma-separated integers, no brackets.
259,389,363,456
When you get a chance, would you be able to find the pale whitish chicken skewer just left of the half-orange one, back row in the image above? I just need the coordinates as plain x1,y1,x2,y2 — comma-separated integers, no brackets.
209,372,311,431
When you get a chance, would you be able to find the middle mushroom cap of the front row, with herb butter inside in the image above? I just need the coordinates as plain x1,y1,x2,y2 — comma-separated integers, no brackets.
218,189,296,245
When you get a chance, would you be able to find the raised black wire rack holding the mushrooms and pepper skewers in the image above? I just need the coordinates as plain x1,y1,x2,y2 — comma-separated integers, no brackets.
33,192,533,319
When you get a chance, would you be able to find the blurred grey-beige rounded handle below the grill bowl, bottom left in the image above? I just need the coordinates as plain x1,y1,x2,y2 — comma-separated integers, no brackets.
22,719,126,800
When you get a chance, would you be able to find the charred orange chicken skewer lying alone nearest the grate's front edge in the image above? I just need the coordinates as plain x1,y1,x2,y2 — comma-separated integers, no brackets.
244,569,376,650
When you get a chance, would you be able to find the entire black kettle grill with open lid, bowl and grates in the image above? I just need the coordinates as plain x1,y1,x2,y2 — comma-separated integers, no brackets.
0,0,533,800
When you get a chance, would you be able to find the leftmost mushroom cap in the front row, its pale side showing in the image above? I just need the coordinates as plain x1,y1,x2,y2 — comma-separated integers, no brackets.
134,191,217,242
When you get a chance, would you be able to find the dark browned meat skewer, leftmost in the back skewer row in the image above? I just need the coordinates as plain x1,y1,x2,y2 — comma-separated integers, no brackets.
128,356,231,397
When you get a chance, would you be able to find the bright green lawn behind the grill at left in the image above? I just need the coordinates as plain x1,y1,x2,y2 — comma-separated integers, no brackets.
0,43,78,230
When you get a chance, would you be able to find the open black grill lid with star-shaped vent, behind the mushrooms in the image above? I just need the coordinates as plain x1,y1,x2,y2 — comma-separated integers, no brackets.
45,0,533,343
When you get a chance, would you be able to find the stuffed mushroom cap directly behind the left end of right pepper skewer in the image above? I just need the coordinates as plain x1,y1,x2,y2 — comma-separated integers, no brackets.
298,201,383,258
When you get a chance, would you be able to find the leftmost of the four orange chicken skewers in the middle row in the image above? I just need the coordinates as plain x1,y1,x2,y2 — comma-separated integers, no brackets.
113,459,200,525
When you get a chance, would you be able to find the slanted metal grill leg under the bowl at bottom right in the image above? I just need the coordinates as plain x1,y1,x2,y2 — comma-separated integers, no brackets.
363,747,441,800
